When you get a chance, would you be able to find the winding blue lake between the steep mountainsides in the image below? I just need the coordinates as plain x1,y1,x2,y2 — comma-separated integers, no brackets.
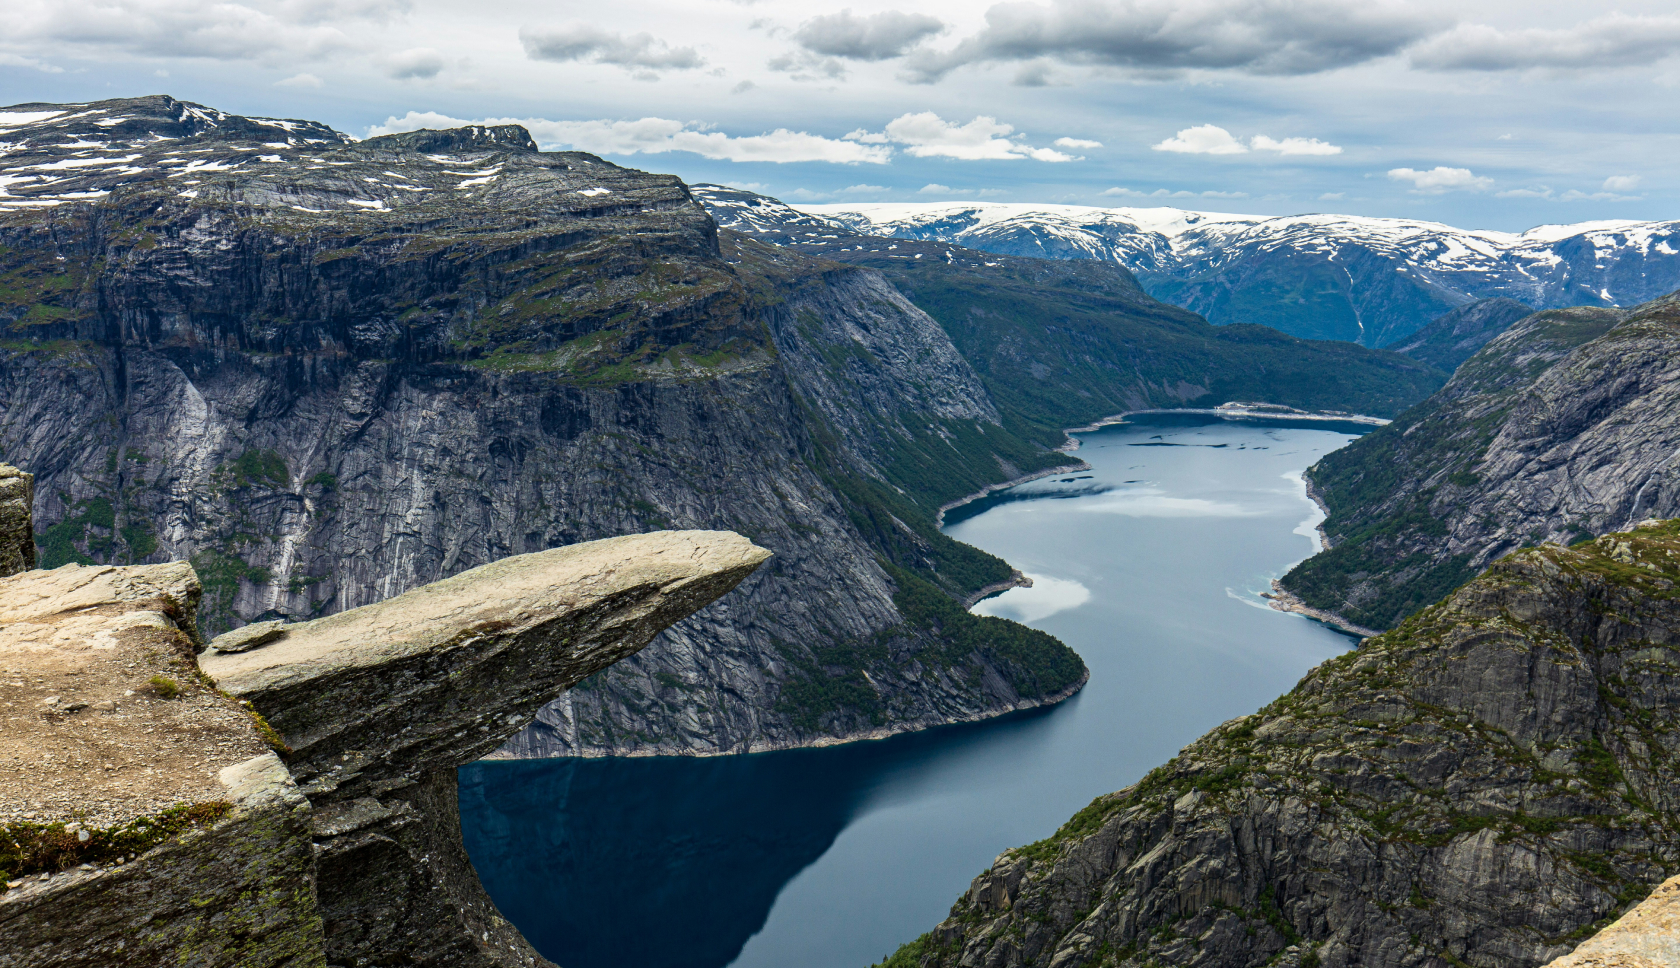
460,415,1366,968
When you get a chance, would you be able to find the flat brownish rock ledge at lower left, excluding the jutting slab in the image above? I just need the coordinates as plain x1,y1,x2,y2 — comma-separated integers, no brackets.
0,563,323,968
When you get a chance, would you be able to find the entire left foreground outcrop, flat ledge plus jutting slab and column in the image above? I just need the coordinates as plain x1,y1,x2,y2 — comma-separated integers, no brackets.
0,520,769,968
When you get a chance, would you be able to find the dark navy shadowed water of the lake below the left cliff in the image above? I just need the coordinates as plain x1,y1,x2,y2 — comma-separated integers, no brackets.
460,697,1077,968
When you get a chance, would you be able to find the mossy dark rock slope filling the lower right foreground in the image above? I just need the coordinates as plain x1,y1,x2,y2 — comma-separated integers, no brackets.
894,521,1680,968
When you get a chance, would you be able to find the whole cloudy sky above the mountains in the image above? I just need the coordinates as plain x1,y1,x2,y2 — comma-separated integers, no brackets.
0,0,1680,230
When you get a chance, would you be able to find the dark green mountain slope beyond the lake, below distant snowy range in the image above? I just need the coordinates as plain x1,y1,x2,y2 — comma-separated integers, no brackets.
692,185,1445,445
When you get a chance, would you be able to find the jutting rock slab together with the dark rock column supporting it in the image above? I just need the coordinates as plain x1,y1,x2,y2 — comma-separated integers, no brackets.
200,531,769,968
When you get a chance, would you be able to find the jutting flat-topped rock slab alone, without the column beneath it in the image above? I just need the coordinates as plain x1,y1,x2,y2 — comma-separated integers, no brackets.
200,531,769,798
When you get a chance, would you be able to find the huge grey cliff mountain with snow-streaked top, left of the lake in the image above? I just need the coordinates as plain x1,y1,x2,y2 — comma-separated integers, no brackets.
0,97,1084,753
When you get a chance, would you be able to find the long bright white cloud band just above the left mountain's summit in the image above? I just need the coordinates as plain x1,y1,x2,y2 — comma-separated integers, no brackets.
368,111,892,165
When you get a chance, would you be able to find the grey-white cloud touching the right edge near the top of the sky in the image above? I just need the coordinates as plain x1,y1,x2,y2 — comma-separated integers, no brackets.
1408,13,1680,71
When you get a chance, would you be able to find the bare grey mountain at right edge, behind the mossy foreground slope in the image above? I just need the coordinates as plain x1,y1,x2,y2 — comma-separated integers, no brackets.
1282,296,1680,629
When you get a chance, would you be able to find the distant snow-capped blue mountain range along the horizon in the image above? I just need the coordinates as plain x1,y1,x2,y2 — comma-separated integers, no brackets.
803,202,1680,346
